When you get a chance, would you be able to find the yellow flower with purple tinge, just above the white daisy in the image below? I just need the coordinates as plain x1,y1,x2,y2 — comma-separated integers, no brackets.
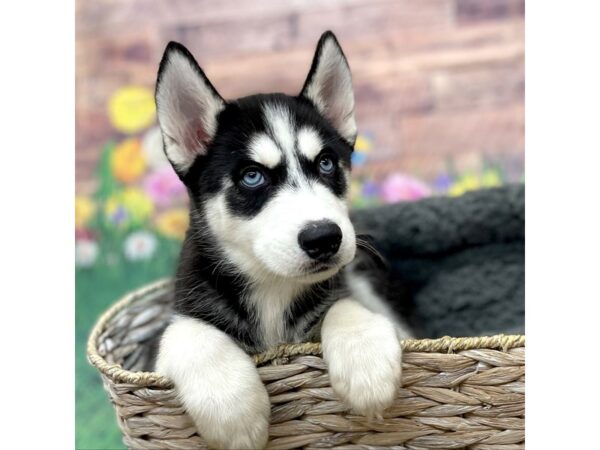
104,187,154,228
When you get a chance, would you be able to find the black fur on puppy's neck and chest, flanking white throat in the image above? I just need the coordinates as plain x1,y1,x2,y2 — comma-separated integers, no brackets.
175,213,356,352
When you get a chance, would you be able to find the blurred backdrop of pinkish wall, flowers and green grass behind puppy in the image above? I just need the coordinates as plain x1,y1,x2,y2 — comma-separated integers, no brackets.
75,0,524,449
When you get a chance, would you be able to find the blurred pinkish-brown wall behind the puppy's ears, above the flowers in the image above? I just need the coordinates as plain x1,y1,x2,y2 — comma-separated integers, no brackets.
76,0,524,191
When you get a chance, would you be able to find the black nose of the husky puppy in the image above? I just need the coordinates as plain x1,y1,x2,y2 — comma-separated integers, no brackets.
298,220,342,261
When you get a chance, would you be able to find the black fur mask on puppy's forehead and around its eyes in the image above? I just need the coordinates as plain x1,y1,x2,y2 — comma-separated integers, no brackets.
183,94,352,217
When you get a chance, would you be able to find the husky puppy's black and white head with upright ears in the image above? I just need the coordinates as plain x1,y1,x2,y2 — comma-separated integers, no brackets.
156,32,356,282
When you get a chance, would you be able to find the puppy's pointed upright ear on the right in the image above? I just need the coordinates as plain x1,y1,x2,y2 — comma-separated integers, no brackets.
300,31,356,145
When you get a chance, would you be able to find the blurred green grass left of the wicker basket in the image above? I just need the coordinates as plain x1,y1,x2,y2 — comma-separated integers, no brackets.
75,240,179,450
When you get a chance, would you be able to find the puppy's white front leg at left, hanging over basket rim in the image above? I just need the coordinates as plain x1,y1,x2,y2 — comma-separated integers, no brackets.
156,317,271,449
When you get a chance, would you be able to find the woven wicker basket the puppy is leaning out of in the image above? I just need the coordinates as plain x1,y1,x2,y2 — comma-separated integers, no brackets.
87,280,525,450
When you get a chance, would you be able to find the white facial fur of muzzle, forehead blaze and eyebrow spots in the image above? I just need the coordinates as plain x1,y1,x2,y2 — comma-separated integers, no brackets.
205,103,356,285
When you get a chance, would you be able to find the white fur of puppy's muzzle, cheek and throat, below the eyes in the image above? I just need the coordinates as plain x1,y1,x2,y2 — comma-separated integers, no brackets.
205,172,356,347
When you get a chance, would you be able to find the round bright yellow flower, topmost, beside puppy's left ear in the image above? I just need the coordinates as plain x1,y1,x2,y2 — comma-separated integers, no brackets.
108,86,156,134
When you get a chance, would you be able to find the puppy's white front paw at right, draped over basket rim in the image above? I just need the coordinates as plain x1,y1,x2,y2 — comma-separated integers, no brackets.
321,298,402,417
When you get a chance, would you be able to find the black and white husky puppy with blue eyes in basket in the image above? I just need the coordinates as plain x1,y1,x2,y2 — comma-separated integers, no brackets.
156,32,407,448
